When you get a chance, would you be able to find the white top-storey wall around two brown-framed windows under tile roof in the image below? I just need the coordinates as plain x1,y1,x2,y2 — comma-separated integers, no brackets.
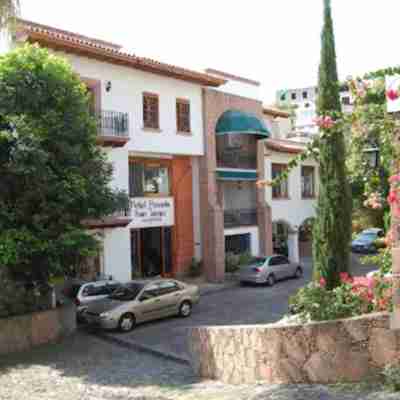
51,52,204,155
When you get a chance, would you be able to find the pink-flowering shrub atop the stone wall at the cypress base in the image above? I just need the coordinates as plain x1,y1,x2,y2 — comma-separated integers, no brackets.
289,273,393,321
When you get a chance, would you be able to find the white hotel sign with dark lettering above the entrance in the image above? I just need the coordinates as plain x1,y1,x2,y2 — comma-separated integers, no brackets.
129,197,175,228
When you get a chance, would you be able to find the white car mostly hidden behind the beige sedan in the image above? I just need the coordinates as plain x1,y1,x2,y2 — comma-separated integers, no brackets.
62,279,121,320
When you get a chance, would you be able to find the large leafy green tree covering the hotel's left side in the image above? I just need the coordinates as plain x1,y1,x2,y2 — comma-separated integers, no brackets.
0,45,127,281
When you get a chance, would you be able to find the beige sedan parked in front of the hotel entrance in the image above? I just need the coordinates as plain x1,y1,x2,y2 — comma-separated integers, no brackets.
84,279,200,332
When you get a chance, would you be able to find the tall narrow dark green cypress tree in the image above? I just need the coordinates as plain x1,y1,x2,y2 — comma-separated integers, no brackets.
313,0,351,289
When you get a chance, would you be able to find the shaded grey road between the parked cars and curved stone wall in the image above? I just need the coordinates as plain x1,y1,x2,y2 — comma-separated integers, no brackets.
101,256,374,359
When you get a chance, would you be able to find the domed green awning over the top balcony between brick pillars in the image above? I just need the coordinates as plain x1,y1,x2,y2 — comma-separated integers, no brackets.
215,110,271,139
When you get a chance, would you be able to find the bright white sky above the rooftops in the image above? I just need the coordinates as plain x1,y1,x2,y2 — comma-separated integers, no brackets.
21,0,400,104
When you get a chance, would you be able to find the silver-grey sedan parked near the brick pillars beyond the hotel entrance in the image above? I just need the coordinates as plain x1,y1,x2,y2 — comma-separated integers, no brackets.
239,255,303,286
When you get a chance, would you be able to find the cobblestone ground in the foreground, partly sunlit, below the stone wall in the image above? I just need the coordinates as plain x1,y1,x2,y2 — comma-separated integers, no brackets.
0,333,400,400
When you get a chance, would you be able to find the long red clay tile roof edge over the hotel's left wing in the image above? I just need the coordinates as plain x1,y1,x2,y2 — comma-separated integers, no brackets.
18,19,226,87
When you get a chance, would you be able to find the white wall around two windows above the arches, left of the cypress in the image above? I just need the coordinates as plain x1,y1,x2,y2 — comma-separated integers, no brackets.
265,150,319,228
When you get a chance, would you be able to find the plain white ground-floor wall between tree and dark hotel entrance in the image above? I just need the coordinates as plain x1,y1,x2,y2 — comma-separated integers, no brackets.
103,228,132,282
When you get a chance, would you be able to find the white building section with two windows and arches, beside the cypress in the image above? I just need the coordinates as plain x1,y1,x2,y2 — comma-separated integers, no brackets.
263,139,319,262
